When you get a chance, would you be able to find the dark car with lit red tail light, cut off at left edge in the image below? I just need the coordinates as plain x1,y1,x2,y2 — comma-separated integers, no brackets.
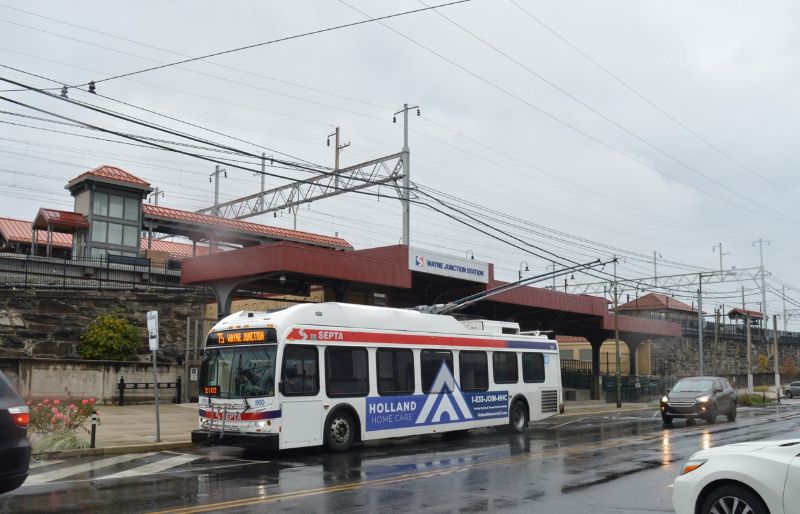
0,372,31,493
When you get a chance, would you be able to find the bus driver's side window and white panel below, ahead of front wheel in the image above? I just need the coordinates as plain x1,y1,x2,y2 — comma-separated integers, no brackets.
280,344,323,448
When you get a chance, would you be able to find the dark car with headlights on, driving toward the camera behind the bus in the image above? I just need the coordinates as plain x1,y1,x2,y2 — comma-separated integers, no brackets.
661,377,737,425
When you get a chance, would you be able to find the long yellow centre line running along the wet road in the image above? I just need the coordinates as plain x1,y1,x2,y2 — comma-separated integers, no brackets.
151,413,800,514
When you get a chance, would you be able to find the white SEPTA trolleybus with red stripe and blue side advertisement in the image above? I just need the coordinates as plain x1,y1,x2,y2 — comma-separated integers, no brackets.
192,303,563,451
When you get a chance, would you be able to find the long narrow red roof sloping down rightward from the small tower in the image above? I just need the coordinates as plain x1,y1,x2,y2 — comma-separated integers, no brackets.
142,204,353,250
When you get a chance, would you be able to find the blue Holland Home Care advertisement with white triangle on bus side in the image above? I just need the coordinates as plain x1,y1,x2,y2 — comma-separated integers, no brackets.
366,362,508,432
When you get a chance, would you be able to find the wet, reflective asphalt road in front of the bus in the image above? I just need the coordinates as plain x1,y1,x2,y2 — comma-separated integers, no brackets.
0,400,800,514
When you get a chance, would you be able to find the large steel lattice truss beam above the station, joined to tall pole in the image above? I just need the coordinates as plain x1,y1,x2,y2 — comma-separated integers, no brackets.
197,152,404,219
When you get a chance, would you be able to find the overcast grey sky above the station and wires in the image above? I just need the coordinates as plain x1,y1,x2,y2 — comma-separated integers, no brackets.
0,0,800,328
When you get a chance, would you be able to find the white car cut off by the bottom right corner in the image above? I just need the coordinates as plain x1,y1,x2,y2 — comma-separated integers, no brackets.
672,439,800,514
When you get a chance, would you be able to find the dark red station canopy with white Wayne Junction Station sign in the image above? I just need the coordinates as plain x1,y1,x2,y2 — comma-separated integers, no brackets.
181,241,681,392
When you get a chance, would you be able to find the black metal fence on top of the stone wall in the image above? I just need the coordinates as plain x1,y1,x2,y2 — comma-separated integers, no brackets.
0,253,205,292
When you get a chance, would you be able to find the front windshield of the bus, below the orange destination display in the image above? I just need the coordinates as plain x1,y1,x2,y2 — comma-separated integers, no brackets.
200,344,277,398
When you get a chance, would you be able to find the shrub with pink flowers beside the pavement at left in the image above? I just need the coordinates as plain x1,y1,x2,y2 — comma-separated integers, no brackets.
28,398,95,451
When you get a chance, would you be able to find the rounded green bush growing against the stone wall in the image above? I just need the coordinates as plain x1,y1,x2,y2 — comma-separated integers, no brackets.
81,312,141,361
